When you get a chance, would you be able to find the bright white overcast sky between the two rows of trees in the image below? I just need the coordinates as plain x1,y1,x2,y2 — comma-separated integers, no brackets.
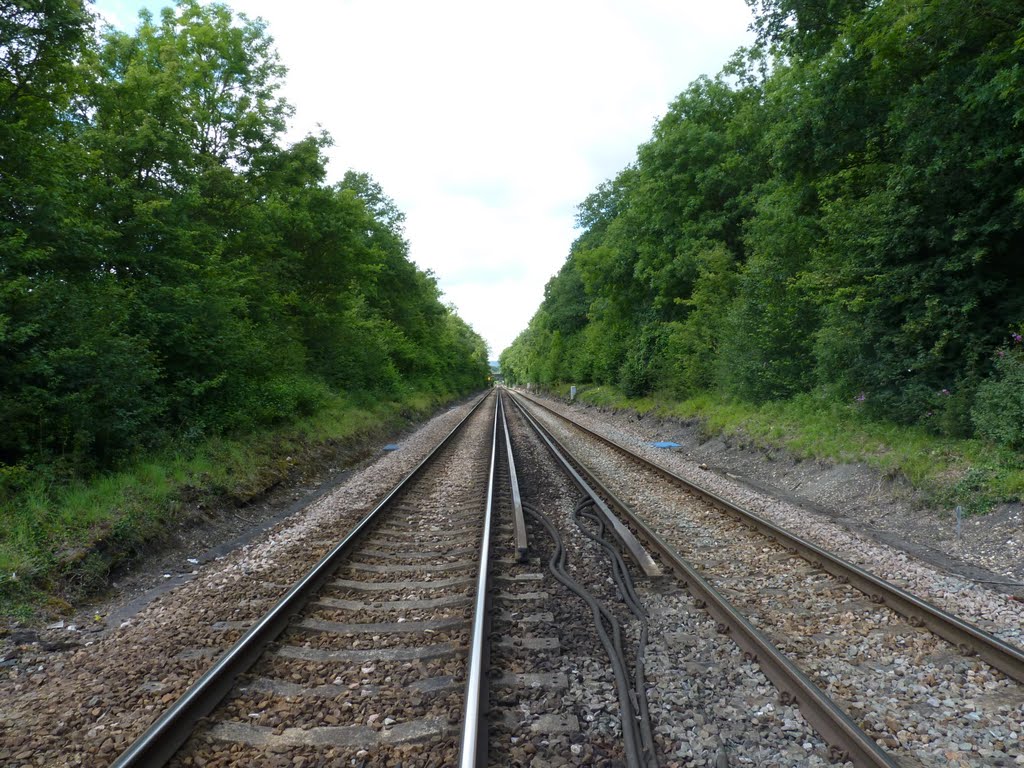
94,0,752,358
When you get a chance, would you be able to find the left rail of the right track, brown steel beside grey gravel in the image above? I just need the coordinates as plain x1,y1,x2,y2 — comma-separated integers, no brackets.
512,395,898,768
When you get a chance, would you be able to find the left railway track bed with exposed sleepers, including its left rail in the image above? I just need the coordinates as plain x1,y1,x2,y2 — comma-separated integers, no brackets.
114,396,495,766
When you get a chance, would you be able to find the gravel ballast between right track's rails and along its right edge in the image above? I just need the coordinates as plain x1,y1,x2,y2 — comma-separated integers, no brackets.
520,393,1024,766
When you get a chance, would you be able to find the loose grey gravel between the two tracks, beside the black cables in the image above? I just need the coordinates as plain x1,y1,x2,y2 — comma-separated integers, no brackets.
508,397,843,768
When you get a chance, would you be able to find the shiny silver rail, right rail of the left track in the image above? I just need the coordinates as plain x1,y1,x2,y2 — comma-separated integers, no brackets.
459,393,501,768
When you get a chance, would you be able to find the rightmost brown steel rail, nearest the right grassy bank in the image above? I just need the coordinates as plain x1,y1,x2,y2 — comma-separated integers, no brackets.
519,393,1024,683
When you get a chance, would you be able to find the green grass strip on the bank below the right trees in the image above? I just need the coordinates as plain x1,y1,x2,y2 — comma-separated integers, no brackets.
569,386,1024,514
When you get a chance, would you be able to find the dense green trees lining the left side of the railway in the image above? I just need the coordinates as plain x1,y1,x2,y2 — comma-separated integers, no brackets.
0,0,487,479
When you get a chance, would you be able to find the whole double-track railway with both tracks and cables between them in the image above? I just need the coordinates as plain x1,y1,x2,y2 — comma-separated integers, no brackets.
81,393,1024,768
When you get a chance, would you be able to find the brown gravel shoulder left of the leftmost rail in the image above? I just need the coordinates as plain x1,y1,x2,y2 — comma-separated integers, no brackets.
0,403,483,768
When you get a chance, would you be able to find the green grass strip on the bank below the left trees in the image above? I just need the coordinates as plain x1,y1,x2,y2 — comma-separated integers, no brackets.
0,387,454,622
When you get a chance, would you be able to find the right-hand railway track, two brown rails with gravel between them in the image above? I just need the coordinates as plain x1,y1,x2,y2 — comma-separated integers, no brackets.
509,391,1024,766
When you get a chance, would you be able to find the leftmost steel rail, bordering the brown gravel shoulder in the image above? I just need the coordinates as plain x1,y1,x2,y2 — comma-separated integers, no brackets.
111,392,489,768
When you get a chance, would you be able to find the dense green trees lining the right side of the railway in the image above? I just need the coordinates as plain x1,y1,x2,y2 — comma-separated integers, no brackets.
502,0,1024,447
